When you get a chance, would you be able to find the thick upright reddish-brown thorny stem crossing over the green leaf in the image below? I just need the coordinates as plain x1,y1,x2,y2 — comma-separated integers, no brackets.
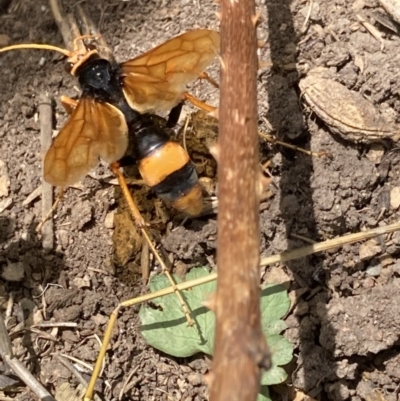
210,0,270,401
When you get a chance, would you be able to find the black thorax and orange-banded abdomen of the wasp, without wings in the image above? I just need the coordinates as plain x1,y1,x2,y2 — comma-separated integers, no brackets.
76,56,202,215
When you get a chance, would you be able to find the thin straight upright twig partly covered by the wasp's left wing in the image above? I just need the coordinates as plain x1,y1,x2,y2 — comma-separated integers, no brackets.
39,93,54,250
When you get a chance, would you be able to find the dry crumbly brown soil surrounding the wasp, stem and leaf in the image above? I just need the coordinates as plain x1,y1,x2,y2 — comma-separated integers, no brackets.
0,0,400,401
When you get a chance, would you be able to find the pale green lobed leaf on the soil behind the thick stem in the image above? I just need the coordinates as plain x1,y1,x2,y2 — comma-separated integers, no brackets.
139,268,293,388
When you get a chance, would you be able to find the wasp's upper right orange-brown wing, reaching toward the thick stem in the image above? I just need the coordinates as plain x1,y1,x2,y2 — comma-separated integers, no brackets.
121,29,220,113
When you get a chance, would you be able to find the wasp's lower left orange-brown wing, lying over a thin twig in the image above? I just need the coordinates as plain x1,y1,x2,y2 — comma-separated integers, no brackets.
44,97,128,187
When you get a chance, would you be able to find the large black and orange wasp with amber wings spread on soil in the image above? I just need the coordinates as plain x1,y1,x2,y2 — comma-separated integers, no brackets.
0,29,219,217
